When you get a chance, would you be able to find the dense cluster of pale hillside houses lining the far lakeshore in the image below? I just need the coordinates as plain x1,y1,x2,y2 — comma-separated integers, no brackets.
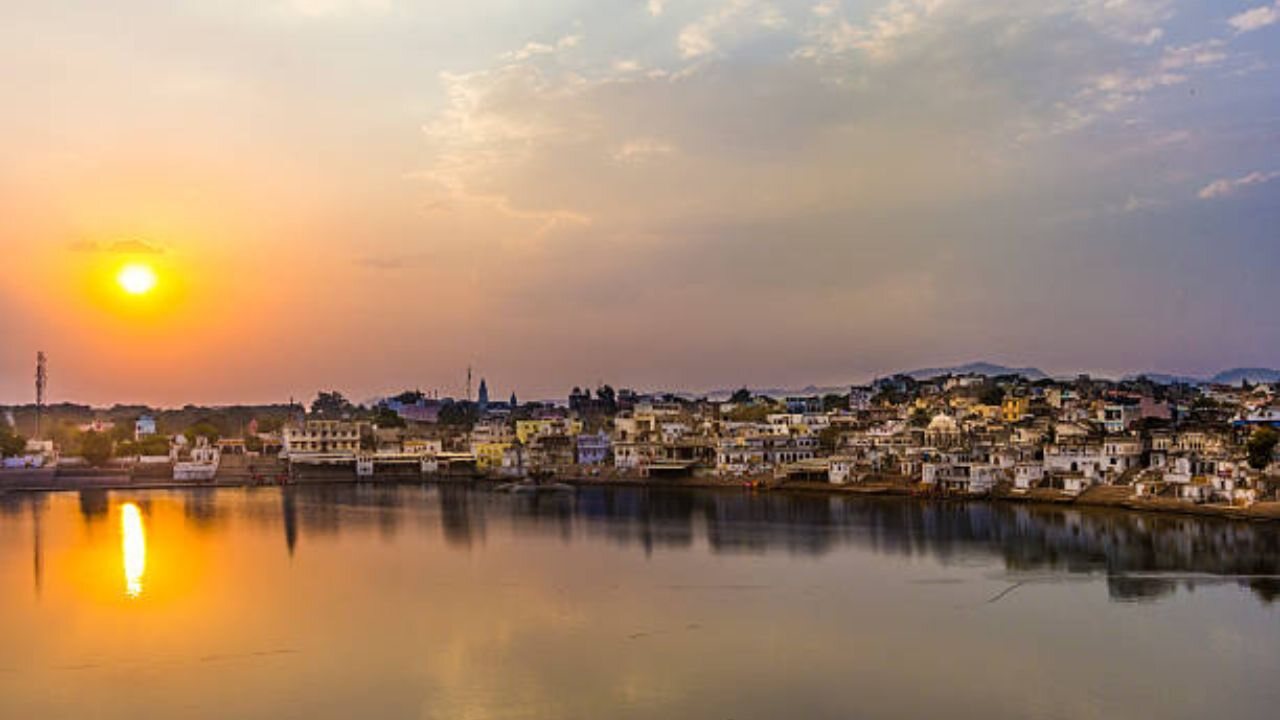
4,366,1280,503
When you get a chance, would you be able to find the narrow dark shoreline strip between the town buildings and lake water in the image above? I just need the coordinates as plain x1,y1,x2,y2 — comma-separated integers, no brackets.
0,473,1280,523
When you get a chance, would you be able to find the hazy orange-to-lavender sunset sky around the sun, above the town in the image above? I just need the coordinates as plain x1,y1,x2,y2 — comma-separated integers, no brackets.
0,0,1280,404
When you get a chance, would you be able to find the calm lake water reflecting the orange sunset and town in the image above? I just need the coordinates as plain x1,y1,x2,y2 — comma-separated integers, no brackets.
0,486,1280,720
